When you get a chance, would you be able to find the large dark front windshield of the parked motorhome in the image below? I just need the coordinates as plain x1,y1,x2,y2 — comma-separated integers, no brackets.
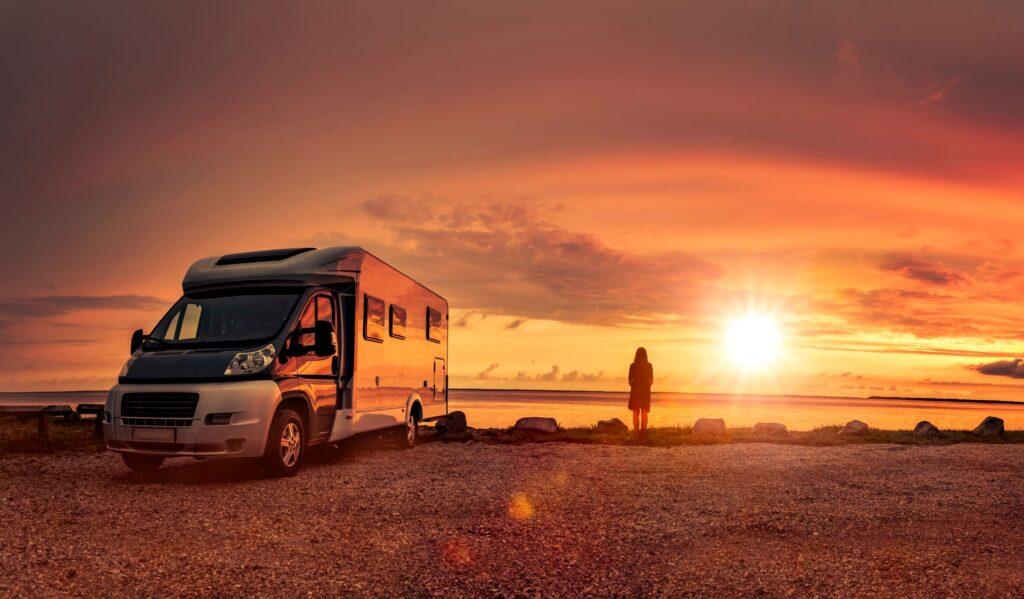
150,290,300,346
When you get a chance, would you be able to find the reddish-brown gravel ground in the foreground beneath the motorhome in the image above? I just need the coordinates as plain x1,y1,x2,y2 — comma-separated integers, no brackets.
0,436,1024,597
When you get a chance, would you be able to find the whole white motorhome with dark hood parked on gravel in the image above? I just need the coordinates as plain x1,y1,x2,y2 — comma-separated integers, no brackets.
103,248,447,474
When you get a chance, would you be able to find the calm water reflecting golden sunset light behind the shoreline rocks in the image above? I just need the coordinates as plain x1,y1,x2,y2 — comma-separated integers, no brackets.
0,390,1024,430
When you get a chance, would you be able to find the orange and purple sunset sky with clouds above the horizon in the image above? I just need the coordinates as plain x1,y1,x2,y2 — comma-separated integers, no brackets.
0,0,1024,400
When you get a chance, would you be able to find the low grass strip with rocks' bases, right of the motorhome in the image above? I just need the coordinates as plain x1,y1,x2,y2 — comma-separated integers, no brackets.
473,426,1024,447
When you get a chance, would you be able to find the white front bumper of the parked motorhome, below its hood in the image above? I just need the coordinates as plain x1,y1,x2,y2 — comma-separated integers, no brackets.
103,381,281,458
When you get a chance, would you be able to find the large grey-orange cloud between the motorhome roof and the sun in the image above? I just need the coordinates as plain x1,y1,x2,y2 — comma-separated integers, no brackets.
344,199,722,329
